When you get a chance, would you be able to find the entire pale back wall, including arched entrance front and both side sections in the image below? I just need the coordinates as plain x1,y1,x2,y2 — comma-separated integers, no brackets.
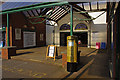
46,12,107,48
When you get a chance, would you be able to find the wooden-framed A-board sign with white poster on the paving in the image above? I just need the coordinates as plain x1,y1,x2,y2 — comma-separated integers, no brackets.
46,45,56,61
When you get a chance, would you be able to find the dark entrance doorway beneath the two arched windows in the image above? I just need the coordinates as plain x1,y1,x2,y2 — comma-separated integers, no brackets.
60,32,88,47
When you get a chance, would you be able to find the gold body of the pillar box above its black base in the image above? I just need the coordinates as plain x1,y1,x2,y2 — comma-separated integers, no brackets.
67,36,78,63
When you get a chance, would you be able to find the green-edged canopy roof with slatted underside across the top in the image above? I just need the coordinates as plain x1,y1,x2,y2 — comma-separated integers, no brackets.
0,1,106,22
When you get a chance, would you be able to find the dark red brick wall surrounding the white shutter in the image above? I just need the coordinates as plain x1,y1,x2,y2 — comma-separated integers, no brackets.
3,12,46,49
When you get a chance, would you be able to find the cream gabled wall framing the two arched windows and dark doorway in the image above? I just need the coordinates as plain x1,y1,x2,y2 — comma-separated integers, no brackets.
56,12,91,47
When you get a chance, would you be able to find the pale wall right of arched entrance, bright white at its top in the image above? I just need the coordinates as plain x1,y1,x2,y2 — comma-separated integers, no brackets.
90,12,107,48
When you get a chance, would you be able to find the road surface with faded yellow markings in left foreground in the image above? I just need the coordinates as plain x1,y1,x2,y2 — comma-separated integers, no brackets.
2,59,67,80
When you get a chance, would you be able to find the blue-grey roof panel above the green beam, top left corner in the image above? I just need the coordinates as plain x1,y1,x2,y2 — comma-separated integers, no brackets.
0,2,40,10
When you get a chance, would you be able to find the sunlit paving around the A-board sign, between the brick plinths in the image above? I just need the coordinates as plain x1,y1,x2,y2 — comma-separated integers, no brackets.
12,47,66,66
